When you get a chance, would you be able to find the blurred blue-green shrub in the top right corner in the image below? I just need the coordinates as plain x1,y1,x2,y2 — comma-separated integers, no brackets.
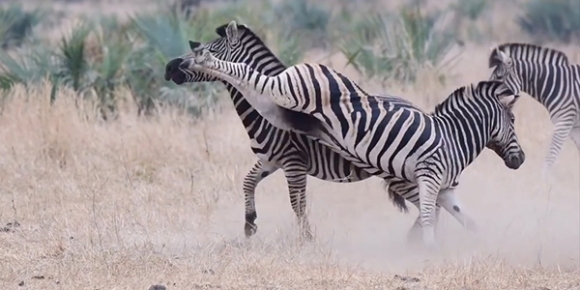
517,0,580,43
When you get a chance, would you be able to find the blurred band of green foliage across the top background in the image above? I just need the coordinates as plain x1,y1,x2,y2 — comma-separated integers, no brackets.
0,0,580,119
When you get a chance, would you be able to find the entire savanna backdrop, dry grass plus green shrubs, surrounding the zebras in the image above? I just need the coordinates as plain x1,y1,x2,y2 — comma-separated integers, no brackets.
0,0,580,290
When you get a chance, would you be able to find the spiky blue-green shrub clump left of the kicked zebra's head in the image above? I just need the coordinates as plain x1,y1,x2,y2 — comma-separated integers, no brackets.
0,7,238,116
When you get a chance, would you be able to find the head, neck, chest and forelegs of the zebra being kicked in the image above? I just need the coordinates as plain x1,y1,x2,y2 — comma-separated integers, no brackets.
165,22,390,239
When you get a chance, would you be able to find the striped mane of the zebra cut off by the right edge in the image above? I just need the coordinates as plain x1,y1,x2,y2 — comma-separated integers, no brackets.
488,42,569,68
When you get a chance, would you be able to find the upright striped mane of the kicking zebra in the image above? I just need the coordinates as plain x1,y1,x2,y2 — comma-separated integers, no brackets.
431,81,513,115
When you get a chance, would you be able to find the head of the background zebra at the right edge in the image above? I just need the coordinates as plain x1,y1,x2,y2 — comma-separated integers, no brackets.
489,48,522,97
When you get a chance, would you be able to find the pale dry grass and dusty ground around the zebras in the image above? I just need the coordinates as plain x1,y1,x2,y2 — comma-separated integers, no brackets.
0,1,580,290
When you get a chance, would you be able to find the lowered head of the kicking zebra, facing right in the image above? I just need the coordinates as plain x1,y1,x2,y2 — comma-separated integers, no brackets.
486,82,526,169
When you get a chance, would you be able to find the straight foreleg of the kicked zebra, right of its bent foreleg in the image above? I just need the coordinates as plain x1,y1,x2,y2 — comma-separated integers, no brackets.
284,162,313,241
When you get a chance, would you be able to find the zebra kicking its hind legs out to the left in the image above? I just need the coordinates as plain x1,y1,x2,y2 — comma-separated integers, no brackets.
179,44,525,247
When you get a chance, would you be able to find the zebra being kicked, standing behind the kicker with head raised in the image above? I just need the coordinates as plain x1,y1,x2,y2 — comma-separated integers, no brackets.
165,21,490,241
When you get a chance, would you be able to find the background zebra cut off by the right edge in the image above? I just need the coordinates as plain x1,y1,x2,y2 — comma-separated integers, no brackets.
488,43,580,176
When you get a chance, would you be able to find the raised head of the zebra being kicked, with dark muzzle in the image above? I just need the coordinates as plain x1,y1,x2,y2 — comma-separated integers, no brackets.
165,20,253,85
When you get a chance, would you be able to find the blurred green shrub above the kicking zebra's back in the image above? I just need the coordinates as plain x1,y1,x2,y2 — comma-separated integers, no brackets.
340,7,454,83
